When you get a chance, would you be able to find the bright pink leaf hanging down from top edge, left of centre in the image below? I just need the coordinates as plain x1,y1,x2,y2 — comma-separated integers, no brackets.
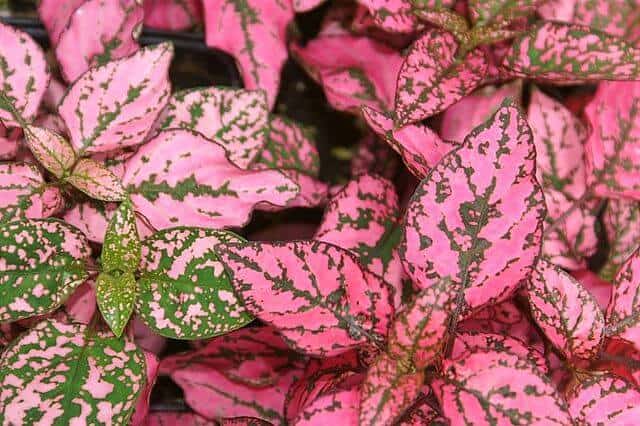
204,0,294,108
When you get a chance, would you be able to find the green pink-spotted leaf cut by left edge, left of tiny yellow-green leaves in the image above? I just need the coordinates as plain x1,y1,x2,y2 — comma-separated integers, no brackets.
0,219,91,322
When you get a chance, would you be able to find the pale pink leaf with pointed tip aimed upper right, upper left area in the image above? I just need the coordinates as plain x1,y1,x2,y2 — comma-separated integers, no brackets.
58,43,173,155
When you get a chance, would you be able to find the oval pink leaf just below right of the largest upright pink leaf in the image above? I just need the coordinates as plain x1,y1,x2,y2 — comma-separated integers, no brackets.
527,259,604,361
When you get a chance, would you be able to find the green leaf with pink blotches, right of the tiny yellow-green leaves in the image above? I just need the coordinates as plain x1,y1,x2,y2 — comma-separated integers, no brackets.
136,228,253,339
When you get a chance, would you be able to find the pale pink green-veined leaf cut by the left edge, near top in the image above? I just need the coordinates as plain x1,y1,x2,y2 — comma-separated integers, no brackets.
0,23,50,126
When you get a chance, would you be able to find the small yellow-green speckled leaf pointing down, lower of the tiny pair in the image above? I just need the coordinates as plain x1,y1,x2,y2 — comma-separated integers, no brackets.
96,272,138,337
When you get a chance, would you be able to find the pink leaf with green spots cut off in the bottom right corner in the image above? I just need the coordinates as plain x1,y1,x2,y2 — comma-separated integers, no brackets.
567,373,640,425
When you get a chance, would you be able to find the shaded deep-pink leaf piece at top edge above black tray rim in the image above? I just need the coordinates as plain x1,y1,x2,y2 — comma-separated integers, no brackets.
144,0,202,31
